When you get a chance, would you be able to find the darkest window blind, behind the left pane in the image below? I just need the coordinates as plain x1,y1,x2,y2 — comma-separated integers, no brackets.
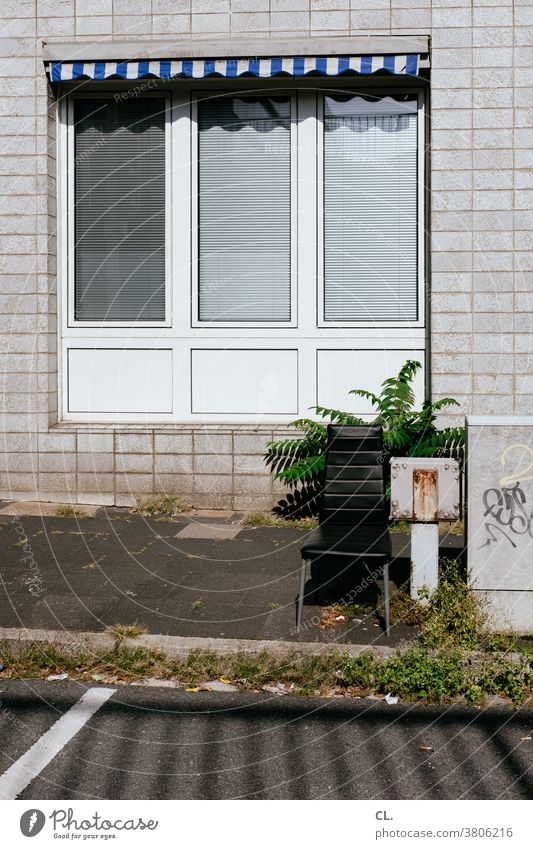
74,98,165,322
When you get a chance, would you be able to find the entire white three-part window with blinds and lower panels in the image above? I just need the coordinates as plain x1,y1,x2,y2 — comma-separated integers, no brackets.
58,88,426,422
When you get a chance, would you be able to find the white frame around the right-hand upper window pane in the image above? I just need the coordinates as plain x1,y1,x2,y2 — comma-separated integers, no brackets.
316,88,426,328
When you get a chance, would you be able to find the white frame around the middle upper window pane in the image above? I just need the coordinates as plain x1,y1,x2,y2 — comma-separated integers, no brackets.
190,89,298,329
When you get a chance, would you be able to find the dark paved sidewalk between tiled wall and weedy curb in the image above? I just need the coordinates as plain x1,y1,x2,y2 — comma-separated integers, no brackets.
0,505,462,645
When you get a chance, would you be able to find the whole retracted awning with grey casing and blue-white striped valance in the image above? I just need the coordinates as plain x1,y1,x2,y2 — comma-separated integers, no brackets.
43,36,429,83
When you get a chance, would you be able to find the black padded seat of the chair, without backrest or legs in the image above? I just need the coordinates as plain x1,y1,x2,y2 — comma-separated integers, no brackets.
302,522,390,558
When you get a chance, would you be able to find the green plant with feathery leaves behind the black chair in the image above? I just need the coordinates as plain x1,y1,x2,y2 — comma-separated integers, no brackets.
264,360,464,518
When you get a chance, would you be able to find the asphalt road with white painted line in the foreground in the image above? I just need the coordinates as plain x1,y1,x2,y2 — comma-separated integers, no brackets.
0,681,533,800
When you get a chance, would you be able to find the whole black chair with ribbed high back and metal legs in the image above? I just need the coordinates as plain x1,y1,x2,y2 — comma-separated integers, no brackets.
296,425,391,635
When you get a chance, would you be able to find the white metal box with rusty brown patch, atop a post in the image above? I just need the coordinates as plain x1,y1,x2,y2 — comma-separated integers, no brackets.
390,457,461,522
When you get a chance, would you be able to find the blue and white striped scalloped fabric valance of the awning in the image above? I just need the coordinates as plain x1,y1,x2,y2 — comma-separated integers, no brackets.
48,53,420,83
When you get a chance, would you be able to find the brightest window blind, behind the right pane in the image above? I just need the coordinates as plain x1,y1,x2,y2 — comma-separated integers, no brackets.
324,97,418,323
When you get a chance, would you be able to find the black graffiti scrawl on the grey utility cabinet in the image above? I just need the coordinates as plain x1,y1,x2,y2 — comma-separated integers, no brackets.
478,484,533,550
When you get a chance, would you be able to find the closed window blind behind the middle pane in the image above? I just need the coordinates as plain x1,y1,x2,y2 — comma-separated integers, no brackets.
198,97,291,322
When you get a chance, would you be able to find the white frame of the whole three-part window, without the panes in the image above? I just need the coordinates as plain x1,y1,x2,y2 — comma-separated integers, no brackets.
57,79,429,427
